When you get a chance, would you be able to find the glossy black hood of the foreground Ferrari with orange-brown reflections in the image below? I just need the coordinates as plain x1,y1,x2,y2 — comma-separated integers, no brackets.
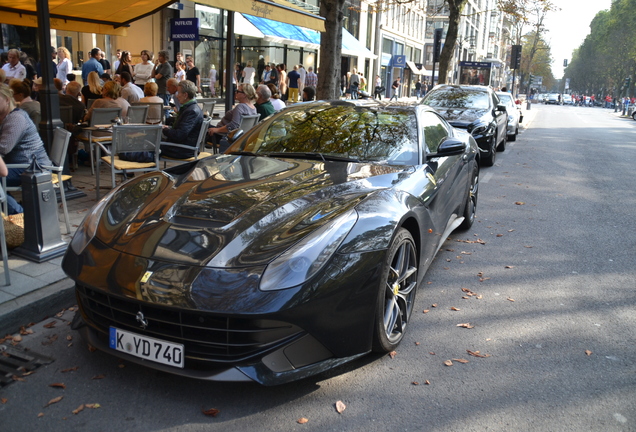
96,155,412,268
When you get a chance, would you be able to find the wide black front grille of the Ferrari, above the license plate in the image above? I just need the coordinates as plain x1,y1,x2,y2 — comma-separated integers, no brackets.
77,285,303,362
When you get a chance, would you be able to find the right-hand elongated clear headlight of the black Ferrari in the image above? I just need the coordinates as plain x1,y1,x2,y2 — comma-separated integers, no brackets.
260,209,358,291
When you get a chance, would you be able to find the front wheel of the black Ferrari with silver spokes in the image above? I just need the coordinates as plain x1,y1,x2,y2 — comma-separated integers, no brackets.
373,228,418,353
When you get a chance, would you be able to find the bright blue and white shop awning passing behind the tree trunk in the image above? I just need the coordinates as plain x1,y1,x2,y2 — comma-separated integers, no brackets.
239,14,376,58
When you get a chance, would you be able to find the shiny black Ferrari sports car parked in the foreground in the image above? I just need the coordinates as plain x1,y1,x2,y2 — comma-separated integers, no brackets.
62,100,481,385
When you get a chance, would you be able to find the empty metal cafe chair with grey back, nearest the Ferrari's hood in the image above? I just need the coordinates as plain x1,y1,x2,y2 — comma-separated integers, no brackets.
95,125,161,200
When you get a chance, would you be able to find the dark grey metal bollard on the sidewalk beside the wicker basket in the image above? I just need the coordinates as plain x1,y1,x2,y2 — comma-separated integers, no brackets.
13,156,67,263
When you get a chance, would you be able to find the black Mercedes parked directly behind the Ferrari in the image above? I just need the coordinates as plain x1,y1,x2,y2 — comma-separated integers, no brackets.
421,84,508,166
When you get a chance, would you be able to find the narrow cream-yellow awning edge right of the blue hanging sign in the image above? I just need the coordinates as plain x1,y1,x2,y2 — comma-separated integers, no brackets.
196,0,325,32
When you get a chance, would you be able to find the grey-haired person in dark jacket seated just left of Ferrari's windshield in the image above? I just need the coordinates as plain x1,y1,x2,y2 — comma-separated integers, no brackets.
119,80,203,162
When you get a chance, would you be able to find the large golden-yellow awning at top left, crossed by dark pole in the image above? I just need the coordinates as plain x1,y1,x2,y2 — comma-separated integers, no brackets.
0,0,177,36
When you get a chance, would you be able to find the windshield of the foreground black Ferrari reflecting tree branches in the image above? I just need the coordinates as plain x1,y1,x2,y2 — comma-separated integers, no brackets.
228,104,418,164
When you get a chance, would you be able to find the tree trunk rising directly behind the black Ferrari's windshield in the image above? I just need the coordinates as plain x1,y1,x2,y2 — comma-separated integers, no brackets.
316,0,345,100
